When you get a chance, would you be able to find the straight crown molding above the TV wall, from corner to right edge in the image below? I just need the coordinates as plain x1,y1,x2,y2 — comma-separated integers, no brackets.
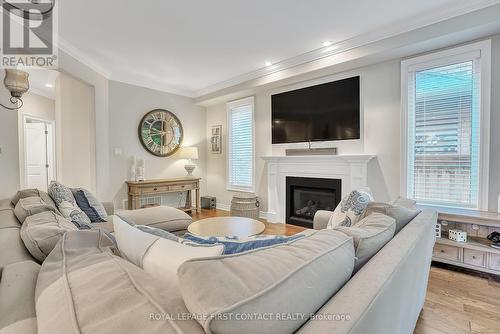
194,0,500,98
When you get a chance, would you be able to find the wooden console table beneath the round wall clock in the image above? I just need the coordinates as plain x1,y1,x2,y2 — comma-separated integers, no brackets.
127,177,200,211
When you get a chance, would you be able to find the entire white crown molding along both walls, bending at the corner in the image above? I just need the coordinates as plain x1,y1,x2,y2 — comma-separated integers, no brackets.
57,0,500,98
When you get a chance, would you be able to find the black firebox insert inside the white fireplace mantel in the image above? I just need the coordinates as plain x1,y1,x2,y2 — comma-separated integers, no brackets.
286,176,342,228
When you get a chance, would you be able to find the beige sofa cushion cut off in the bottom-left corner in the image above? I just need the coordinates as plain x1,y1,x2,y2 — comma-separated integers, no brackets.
0,261,40,334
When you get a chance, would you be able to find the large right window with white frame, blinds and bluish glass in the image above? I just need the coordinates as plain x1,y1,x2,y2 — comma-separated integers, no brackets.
401,41,490,209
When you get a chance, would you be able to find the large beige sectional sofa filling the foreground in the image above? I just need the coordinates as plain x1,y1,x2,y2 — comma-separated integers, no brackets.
0,190,437,334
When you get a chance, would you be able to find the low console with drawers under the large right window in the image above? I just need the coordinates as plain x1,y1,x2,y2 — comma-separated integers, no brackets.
432,208,500,275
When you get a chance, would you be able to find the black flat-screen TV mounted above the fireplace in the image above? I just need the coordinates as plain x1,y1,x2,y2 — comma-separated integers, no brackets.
271,76,360,144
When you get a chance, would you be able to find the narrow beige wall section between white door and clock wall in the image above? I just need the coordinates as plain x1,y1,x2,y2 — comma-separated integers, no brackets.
55,74,97,192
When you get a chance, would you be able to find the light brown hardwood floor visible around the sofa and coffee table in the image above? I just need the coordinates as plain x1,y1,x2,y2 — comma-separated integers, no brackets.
189,210,500,334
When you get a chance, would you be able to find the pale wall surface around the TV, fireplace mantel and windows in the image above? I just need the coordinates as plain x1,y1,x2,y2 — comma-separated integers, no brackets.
207,35,500,212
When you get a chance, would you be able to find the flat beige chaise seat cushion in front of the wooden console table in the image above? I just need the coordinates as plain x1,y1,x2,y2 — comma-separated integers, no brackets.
118,206,193,232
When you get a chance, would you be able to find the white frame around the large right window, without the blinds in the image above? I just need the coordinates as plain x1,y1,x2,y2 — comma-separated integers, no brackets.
400,40,491,211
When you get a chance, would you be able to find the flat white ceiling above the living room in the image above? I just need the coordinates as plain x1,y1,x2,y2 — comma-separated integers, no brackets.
58,0,499,96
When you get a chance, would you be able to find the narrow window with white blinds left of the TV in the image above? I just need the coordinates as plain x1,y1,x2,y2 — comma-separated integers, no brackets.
227,97,254,192
